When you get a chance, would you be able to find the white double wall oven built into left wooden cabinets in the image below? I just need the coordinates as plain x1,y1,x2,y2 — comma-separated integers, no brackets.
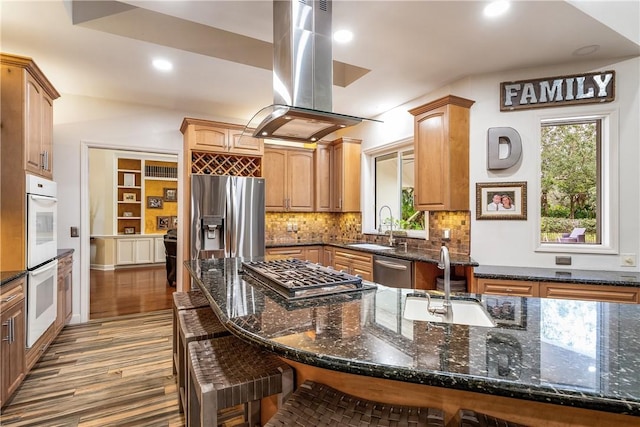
25,174,58,347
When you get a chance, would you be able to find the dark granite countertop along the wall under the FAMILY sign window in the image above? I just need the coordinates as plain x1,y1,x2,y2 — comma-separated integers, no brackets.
474,265,640,287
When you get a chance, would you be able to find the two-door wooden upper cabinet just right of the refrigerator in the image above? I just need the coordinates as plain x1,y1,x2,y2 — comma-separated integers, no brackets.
263,147,313,212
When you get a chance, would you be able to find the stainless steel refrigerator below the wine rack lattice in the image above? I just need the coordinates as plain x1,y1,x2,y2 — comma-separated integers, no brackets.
190,175,265,259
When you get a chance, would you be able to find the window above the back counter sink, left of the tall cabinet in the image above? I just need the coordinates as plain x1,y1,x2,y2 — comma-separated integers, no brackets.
374,146,424,234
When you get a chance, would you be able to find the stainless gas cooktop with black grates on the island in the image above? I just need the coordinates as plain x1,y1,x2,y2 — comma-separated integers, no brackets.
242,258,370,299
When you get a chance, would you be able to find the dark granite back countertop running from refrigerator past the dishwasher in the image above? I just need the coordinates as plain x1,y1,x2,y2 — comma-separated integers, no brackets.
266,239,478,266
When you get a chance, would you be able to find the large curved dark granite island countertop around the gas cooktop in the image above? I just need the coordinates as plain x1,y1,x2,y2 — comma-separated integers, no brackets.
185,258,640,423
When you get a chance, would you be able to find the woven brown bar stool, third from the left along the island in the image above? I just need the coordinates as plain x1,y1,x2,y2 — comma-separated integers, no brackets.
185,336,293,427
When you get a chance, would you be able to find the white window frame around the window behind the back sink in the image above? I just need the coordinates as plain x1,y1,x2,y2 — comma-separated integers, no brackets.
362,140,429,240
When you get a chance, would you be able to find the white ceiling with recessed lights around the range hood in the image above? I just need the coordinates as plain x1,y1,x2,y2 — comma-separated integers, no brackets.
0,0,640,123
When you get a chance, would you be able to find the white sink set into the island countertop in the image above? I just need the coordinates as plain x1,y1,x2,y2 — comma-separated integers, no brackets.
404,296,496,328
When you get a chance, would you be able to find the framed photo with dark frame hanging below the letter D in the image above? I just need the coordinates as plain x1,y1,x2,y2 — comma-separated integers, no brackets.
476,182,527,220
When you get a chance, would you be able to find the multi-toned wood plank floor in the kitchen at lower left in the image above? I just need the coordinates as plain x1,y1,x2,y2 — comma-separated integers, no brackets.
0,310,184,427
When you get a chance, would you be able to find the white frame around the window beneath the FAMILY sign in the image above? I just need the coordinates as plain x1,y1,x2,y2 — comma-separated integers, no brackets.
530,107,620,254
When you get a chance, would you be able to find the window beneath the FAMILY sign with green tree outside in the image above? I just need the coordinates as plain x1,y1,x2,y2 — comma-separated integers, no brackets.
539,115,617,252
